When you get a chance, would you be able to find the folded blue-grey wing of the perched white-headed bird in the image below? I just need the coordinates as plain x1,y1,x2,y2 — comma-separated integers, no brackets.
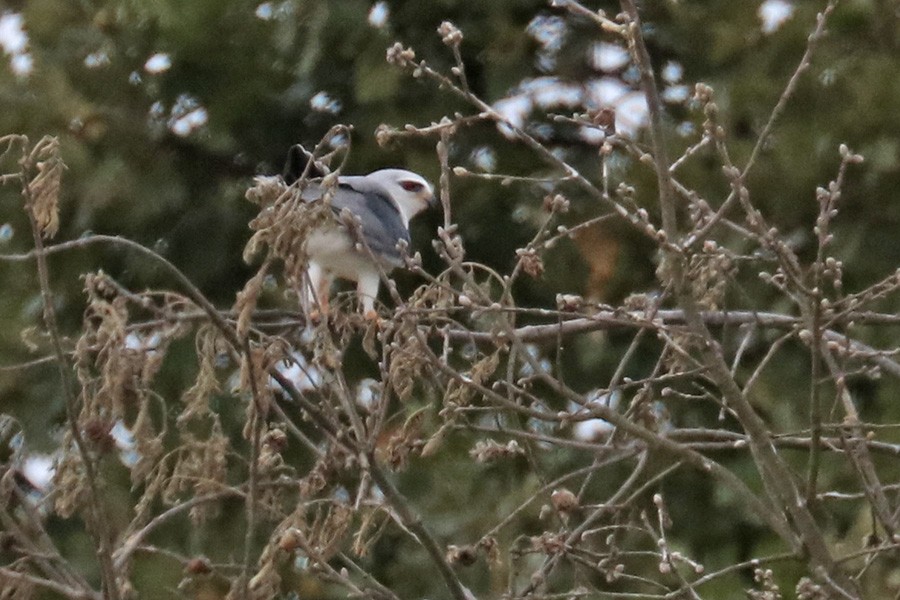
302,176,410,266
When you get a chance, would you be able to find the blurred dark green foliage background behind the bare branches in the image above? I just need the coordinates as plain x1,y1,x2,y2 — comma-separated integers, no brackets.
0,0,900,598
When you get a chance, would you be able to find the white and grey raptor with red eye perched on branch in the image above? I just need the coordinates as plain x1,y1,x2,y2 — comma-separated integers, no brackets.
283,146,437,320
